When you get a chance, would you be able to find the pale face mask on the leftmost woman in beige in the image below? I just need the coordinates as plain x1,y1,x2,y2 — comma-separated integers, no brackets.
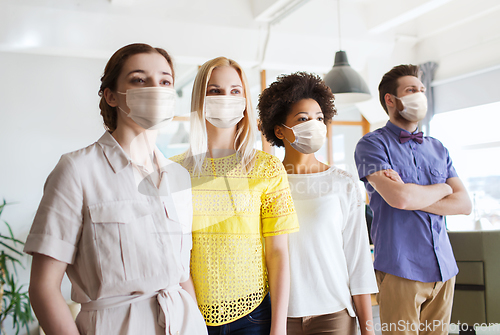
118,87,177,130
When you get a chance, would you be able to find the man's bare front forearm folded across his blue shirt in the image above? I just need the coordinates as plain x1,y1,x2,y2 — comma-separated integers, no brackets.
366,170,453,211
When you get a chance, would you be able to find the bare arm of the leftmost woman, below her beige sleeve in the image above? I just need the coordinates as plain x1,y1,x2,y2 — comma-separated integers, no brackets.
29,253,79,335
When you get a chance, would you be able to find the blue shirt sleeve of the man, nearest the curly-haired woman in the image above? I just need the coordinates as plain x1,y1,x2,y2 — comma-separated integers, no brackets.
354,133,392,181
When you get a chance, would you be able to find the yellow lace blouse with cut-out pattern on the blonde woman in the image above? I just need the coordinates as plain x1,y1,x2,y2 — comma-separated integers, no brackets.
171,151,299,326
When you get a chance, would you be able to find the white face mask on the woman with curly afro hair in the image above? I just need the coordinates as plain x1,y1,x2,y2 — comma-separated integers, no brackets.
283,120,326,154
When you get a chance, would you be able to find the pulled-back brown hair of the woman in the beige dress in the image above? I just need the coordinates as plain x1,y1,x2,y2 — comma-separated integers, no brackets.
99,43,175,132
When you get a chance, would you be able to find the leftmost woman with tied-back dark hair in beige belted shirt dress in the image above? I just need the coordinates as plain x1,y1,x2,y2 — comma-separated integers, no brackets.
24,44,206,335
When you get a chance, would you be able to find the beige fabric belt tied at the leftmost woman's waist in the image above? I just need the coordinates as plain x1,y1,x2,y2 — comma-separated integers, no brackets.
82,284,183,335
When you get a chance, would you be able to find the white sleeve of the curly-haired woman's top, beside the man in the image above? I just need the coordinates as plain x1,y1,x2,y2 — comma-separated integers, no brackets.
342,179,378,295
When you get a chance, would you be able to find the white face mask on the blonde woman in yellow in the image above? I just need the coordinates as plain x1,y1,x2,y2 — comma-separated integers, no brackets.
205,95,247,128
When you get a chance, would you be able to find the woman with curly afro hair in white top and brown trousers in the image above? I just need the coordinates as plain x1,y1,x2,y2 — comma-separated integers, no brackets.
258,72,377,335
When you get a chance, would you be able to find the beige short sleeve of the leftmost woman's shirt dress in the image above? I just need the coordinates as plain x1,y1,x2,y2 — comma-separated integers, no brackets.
24,155,83,264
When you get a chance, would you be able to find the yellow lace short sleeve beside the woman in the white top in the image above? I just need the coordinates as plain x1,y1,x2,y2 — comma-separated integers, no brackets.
261,156,299,237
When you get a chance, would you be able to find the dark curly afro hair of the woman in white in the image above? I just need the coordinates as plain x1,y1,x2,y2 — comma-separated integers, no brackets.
257,72,337,147
